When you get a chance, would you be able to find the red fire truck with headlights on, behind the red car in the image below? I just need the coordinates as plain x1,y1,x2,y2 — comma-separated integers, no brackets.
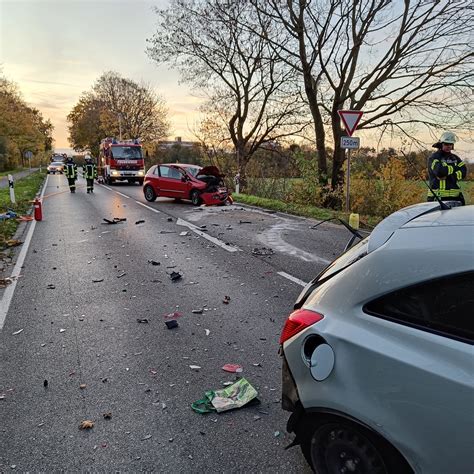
97,138,145,184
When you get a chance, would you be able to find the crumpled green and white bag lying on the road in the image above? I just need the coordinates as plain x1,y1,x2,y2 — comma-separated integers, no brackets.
191,378,258,413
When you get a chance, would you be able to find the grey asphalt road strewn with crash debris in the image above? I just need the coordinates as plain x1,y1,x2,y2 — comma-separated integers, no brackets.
0,175,360,473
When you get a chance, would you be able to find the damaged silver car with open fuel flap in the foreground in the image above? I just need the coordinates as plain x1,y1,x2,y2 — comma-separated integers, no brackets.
280,202,474,474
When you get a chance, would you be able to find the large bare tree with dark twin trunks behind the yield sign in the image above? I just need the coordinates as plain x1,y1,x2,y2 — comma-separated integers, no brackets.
251,0,473,194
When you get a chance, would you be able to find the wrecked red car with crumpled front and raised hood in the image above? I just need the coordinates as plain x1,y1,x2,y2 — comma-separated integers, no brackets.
143,163,233,206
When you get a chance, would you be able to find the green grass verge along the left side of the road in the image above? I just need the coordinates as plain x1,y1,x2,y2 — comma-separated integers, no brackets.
0,171,45,250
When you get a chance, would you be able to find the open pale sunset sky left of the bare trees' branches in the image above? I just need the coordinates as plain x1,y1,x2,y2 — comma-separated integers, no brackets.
0,0,201,148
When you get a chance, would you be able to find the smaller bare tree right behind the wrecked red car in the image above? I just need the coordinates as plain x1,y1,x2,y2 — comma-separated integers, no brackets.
148,0,308,185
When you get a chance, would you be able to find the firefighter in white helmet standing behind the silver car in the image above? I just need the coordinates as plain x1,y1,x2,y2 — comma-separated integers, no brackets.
428,132,467,205
